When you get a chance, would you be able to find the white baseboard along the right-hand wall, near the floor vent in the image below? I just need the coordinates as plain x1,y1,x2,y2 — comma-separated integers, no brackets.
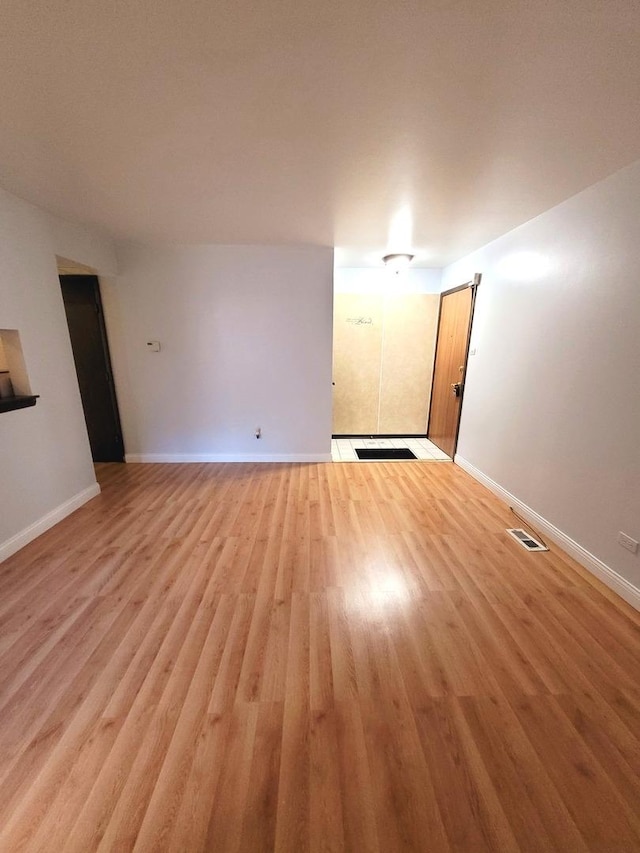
453,455,640,610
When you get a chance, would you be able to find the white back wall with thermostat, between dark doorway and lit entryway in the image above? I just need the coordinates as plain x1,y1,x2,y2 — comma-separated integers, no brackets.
103,244,333,461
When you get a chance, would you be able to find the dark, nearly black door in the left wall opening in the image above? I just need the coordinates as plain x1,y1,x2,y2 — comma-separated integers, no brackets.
60,275,124,462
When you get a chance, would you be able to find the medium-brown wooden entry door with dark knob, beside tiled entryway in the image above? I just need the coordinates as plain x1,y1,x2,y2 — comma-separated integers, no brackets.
427,287,475,457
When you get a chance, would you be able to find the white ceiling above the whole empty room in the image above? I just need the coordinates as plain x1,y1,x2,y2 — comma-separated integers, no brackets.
0,0,640,267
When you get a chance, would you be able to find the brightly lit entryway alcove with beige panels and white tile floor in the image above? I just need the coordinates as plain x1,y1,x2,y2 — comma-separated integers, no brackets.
332,268,448,461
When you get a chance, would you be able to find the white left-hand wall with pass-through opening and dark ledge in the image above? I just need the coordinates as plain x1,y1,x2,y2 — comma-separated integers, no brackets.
0,191,115,559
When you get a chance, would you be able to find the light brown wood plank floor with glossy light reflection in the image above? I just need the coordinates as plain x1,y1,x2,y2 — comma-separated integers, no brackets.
0,463,640,853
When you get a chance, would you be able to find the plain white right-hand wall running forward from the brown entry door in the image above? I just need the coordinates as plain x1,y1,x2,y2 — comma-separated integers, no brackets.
443,156,640,603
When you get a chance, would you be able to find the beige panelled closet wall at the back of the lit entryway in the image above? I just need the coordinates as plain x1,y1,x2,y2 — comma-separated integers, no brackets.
333,293,439,435
